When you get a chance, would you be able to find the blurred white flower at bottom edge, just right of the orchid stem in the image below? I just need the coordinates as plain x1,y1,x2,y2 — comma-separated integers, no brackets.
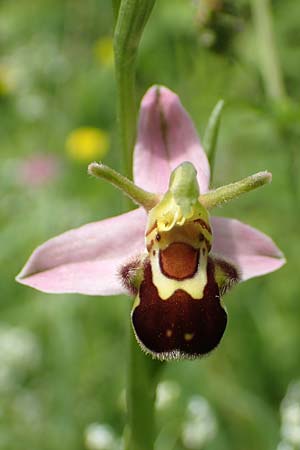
181,395,217,450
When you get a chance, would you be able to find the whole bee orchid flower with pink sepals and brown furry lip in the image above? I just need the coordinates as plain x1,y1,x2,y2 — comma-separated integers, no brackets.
17,86,285,359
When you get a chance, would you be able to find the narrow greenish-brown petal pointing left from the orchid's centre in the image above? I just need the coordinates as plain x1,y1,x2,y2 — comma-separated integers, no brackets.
88,162,159,211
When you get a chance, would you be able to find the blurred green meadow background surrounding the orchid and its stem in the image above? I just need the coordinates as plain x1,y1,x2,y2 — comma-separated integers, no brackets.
0,0,300,450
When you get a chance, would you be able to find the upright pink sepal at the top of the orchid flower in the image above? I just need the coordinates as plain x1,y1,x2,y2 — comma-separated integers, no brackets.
133,86,210,193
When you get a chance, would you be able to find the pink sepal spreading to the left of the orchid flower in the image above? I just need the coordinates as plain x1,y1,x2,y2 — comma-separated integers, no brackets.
17,208,146,295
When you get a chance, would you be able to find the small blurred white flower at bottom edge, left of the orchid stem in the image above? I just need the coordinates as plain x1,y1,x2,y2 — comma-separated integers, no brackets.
85,423,118,450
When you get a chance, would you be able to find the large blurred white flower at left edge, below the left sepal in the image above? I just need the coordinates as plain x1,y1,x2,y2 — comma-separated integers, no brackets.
0,325,41,390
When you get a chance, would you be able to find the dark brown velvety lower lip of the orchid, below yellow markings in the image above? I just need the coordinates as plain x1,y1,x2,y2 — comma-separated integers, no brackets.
132,258,227,359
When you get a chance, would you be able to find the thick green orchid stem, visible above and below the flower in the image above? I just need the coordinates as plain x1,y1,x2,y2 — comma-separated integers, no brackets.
114,0,161,450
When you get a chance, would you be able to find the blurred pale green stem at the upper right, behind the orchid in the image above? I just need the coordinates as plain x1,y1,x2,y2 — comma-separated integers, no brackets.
251,0,286,101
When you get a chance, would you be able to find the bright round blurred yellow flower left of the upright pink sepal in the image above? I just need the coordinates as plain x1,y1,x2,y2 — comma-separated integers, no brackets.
66,127,109,162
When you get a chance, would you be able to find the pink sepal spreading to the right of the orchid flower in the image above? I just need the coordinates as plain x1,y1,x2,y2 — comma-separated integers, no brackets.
212,217,285,280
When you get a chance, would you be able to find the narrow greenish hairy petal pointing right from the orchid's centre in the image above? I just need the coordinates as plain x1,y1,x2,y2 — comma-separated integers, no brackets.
199,172,272,209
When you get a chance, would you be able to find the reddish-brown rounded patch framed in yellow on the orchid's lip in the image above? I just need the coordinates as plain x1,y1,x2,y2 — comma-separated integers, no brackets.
159,242,199,280
